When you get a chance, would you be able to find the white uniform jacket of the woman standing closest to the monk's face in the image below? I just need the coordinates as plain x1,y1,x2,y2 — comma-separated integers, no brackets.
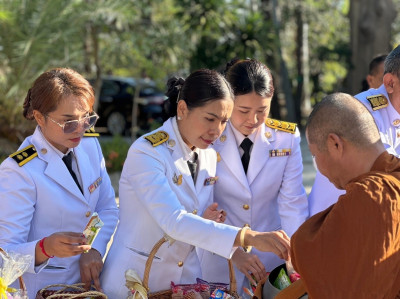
199,123,308,293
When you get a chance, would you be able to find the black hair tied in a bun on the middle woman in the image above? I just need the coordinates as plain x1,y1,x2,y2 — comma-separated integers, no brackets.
165,69,234,117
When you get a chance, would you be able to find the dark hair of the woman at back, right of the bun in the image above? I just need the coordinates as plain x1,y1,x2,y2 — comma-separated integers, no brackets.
225,59,274,97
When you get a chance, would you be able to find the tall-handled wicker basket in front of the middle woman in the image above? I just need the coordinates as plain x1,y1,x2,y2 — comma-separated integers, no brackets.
143,237,239,299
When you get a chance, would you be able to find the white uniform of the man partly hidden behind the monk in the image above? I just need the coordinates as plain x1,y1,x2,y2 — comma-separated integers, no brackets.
308,84,400,216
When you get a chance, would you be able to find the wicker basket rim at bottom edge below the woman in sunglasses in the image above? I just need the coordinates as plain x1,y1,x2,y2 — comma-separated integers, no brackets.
36,283,108,299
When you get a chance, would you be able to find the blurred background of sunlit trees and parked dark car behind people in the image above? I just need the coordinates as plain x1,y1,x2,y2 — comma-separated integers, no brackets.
0,0,400,182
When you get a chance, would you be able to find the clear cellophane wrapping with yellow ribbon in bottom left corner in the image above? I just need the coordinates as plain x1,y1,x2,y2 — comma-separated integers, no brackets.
0,249,33,299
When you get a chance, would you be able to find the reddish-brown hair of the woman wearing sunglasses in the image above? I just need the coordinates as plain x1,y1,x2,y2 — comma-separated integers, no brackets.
23,68,94,120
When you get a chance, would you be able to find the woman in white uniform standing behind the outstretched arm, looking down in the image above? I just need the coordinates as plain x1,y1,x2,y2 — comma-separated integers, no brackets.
199,59,308,291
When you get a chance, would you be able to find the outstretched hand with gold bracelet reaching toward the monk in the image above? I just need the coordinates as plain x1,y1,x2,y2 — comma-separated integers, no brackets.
252,230,290,260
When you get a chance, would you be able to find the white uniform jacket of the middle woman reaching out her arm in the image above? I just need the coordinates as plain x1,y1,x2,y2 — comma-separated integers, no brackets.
101,118,239,299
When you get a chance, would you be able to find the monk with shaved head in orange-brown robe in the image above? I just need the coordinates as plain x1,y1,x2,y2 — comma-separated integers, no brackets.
291,92,400,299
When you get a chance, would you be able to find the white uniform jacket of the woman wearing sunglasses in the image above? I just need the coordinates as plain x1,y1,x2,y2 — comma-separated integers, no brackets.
0,127,118,298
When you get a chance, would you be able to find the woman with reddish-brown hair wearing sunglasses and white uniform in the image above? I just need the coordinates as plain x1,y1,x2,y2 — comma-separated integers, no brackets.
0,68,118,298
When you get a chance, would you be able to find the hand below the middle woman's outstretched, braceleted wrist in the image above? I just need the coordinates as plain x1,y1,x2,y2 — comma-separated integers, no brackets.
232,248,267,284
